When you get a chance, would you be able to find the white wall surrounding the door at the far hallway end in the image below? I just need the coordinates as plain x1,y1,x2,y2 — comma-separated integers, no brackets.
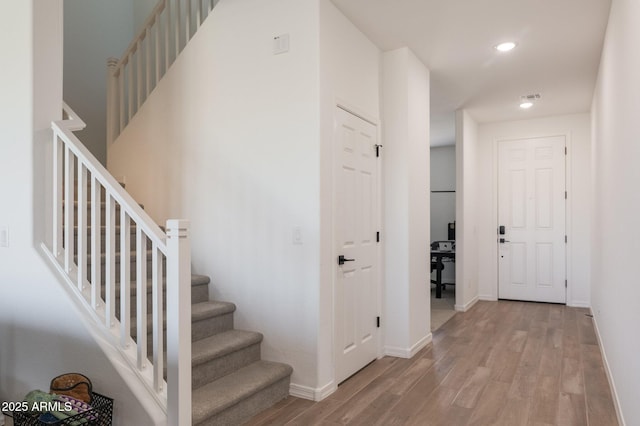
476,113,591,306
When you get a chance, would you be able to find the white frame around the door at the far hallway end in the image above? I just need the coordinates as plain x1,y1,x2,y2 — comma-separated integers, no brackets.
491,131,573,306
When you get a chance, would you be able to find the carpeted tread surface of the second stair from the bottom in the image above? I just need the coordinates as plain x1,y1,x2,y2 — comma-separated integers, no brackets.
191,330,262,367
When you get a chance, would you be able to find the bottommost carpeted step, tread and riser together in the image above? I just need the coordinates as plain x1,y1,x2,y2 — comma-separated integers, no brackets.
192,361,292,426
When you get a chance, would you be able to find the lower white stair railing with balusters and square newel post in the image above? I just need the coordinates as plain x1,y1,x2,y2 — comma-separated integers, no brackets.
48,105,191,425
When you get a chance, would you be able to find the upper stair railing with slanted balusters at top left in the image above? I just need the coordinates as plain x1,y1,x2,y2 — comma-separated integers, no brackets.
107,0,219,143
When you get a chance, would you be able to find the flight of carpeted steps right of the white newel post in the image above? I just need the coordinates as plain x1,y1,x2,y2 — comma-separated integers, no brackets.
191,282,292,425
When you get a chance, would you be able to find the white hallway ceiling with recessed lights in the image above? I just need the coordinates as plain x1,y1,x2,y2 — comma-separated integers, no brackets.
333,0,611,146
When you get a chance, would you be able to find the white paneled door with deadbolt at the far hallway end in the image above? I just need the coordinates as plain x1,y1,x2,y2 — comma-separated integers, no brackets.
498,136,566,303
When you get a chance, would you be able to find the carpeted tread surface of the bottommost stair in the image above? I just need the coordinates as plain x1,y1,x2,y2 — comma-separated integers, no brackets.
192,361,293,425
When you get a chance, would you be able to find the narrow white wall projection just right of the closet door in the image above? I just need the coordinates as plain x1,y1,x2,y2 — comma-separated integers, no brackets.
382,48,431,357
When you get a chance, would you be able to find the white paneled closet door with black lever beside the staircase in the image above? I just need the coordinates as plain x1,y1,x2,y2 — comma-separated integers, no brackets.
334,108,379,383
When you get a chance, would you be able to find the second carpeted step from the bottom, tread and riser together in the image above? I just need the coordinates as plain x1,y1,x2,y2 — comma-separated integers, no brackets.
191,330,262,389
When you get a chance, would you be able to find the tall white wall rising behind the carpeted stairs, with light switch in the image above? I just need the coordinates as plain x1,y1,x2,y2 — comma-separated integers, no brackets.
108,0,321,388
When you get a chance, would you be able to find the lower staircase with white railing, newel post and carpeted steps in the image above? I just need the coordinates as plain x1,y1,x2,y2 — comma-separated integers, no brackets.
48,106,292,426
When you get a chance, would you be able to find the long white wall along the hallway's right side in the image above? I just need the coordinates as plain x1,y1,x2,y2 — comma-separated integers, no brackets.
591,0,640,425
